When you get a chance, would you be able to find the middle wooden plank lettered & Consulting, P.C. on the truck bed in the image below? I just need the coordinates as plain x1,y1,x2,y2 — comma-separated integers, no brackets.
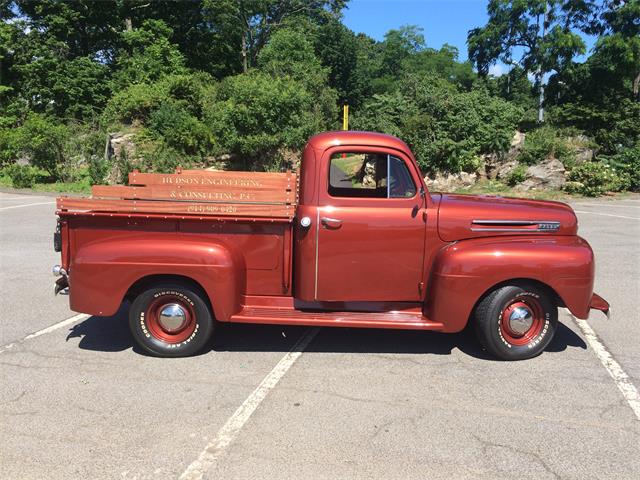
91,185,296,204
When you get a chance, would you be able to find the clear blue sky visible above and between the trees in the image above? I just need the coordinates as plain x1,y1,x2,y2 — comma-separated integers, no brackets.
343,0,593,75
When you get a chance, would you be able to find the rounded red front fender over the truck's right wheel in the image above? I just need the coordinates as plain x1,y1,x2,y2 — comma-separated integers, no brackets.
424,236,594,332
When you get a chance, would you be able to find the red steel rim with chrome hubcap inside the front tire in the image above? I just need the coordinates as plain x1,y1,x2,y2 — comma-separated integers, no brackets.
500,297,545,345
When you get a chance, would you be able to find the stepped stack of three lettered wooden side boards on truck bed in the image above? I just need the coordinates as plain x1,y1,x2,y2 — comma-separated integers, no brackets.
57,169,297,221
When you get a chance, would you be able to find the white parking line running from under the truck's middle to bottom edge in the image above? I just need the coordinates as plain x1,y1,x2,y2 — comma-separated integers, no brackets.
180,328,320,480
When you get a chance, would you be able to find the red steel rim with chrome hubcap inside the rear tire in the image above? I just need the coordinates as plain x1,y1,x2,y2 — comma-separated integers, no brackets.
145,295,196,343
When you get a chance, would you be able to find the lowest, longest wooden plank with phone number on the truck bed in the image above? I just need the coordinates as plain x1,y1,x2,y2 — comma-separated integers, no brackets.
56,197,295,218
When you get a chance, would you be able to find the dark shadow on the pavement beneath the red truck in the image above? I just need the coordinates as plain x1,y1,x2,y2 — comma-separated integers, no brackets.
67,306,587,360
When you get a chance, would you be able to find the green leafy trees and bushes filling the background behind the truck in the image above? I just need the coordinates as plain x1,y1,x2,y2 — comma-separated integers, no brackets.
0,0,640,194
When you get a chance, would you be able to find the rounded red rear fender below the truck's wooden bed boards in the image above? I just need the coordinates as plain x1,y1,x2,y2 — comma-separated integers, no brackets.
69,233,246,321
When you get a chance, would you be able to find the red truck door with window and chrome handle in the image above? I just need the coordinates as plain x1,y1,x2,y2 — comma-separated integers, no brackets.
315,149,426,301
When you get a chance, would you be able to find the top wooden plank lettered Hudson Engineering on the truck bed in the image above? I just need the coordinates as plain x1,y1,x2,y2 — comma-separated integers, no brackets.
129,170,296,191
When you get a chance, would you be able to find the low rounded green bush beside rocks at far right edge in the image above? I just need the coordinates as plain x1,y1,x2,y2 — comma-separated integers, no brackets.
564,162,631,197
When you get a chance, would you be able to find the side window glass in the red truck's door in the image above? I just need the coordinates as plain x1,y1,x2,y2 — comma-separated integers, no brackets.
329,153,416,198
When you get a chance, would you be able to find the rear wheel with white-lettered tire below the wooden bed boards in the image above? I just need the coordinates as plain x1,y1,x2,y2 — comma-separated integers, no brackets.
129,283,214,357
